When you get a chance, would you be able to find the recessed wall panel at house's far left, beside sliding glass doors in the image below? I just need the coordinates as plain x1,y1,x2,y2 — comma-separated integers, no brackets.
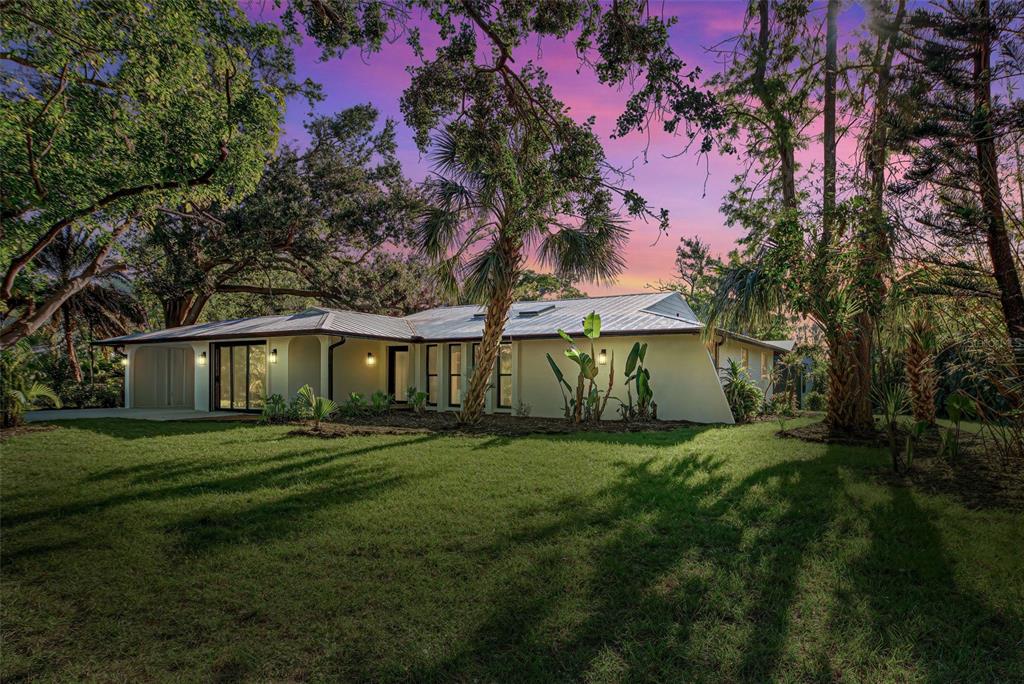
126,344,196,409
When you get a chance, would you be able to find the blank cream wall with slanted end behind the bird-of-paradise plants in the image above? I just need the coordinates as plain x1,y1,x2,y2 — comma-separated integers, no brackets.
513,335,733,423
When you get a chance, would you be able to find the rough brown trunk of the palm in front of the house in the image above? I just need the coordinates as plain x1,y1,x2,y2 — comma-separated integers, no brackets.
459,238,522,424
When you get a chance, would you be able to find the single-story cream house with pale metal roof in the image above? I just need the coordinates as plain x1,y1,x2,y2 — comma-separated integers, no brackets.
98,293,778,423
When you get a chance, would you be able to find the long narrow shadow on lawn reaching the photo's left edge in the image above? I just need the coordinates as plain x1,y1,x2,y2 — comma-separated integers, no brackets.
0,435,436,528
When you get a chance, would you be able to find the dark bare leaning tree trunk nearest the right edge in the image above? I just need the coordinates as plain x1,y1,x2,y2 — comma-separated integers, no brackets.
974,0,1024,374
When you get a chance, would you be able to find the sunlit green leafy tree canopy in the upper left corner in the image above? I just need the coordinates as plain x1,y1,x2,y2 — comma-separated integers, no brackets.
0,0,303,345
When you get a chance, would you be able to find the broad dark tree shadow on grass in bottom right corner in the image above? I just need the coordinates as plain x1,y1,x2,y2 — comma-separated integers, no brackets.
830,486,1024,682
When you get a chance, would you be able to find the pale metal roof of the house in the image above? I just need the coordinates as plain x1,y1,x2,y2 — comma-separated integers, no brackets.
97,292,782,346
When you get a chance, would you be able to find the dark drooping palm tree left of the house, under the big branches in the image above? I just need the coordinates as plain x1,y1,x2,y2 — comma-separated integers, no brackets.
37,228,145,382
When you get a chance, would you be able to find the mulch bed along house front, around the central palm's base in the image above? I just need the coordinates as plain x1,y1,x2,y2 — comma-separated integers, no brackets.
289,411,694,438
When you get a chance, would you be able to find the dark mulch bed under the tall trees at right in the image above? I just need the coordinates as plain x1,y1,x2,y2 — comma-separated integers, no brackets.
779,423,1024,510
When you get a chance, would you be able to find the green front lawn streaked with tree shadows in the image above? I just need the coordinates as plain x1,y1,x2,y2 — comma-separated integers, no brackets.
0,421,1024,682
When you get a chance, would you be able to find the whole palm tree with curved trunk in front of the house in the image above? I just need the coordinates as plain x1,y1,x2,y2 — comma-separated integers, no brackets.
417,122,629,423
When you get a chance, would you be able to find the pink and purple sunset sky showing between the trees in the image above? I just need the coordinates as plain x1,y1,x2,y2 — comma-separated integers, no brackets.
242,0,861,294
